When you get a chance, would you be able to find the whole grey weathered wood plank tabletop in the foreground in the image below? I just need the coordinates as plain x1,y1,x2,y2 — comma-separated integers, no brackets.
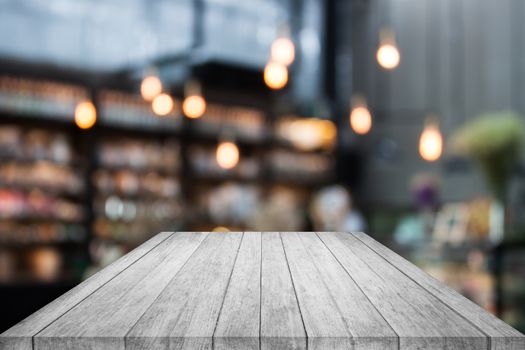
0,232,525,350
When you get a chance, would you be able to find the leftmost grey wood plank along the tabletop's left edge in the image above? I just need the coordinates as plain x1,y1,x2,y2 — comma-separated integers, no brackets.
0,232,172,350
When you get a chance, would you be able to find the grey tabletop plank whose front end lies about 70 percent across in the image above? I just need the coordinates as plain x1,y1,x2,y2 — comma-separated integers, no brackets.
299,232,398,349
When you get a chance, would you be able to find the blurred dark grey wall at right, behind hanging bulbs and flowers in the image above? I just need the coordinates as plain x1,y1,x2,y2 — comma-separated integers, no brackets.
340,0,525,206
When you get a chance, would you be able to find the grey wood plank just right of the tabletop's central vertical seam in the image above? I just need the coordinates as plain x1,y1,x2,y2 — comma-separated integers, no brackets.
260,232,306,350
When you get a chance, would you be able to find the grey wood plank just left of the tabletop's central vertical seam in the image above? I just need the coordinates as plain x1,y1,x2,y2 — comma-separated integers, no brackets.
213,232,261,350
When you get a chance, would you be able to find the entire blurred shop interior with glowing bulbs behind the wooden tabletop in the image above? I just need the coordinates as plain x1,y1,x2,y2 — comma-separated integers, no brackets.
0,0,525,332
